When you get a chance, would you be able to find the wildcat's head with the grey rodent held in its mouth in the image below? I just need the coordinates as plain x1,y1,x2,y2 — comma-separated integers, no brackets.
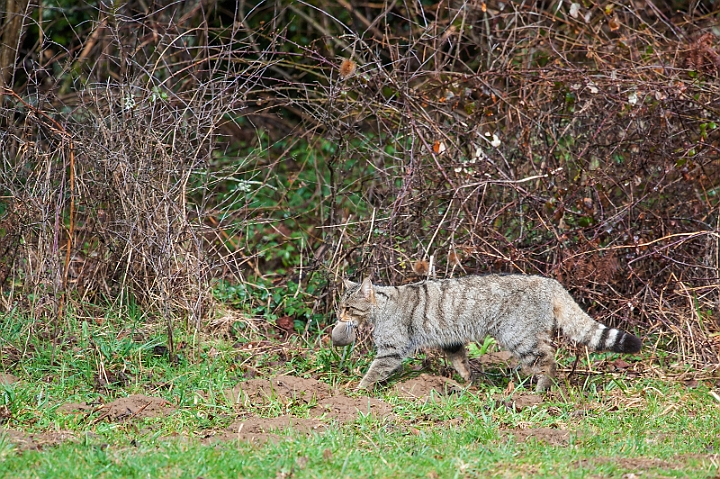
332,278,376,346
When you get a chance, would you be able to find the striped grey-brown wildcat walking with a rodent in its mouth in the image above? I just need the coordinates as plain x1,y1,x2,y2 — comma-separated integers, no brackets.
332,274,642,392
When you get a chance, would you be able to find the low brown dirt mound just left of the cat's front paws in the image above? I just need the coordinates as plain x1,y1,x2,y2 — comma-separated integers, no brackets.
226,376,332,407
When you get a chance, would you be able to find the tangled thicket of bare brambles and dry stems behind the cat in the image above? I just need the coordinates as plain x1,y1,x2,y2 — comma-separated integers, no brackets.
0,0,720,363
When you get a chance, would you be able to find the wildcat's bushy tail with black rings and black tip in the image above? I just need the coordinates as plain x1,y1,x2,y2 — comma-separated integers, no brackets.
553,287,642,353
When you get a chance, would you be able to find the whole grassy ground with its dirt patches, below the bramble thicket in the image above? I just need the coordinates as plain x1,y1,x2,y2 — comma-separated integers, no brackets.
0,325,720,479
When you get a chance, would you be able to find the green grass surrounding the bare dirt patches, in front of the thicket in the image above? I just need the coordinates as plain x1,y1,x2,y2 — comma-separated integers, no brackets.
0,310,720,478
